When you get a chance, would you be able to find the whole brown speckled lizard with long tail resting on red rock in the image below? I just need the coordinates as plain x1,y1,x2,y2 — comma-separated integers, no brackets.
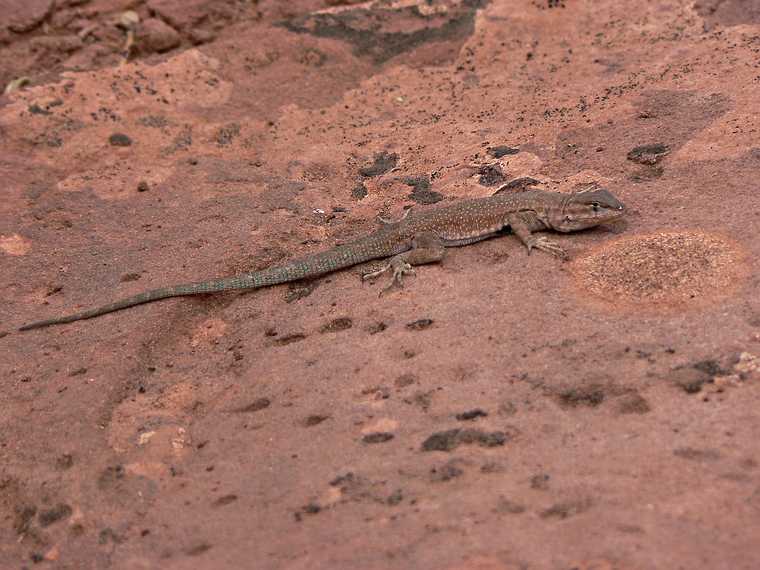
19,185,625,330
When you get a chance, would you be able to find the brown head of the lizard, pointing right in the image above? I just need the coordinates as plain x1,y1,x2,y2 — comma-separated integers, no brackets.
547,188,625,232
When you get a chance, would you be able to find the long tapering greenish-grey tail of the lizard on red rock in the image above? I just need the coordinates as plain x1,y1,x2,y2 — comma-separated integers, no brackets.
19,235,393,331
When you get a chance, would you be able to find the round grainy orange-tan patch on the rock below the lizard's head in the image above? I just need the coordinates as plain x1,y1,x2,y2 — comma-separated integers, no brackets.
573,232,744,307
